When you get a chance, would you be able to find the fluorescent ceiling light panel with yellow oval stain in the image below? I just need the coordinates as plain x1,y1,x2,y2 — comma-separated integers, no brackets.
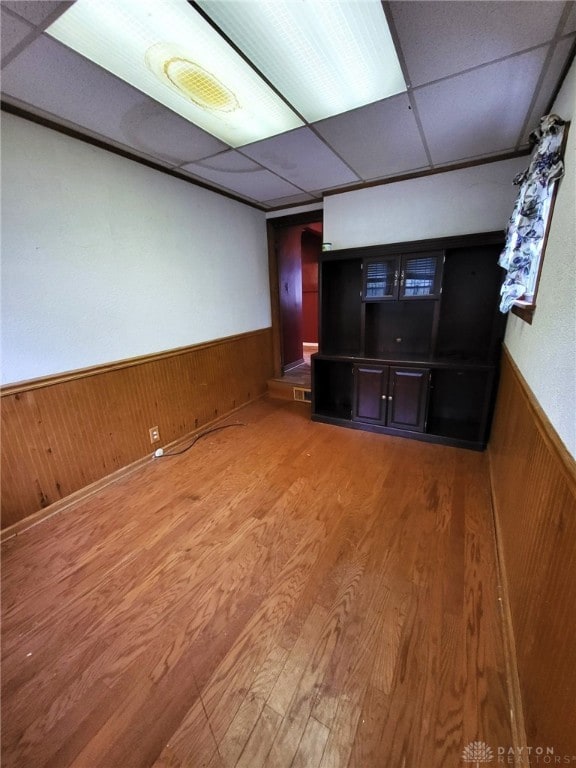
46,0,303,147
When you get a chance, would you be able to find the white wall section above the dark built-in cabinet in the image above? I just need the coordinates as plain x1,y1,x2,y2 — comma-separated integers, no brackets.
323,158,527,248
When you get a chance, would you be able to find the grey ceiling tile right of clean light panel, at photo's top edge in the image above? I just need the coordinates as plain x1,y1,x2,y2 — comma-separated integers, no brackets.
390,0,564,86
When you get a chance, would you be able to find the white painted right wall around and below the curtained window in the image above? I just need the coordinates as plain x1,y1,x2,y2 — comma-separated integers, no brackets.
505,62,576,458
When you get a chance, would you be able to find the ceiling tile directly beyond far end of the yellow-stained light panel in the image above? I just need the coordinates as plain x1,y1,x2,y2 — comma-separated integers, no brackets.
242,128,358,191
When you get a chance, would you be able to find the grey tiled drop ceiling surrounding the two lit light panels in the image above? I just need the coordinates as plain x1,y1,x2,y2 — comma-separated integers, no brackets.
0,0,576,210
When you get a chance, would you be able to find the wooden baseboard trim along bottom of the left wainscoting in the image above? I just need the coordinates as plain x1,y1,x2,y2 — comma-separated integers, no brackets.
0,393,267,543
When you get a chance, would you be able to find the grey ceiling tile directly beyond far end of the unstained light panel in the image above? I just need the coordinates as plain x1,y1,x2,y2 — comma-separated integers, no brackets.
314,94,428,180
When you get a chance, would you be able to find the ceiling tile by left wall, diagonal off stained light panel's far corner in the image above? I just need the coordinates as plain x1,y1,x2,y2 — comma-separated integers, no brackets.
181,150,301,201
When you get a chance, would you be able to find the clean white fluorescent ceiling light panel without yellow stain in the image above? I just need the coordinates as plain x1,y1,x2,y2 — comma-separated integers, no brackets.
198,0,406,122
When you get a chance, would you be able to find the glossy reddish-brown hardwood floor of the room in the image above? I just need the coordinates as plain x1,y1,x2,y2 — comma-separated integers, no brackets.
2,400,511,768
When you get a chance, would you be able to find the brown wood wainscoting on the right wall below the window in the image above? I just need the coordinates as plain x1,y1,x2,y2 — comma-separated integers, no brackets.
489,351,576,765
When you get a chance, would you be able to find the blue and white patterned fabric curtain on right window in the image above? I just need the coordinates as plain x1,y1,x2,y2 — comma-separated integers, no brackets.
498,115,564,312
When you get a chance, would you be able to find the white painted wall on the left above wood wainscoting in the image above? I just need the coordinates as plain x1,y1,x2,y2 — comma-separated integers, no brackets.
2,113,271,383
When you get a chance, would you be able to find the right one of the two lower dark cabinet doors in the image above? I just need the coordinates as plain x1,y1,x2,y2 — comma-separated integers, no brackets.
387,368,430,432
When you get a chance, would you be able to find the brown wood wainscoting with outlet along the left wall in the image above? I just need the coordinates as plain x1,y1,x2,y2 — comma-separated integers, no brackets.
2,328,273,530
